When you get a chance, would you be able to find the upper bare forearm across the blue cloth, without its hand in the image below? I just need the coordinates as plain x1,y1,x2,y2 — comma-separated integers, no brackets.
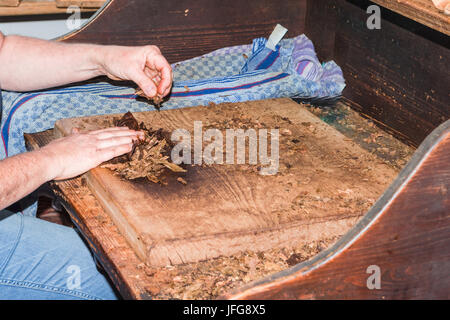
0,34,104,91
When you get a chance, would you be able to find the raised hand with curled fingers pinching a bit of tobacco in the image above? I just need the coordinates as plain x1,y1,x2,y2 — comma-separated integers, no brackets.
100,45,172,98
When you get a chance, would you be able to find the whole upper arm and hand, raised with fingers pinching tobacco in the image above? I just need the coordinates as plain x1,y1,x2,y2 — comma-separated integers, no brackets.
0,33,172,97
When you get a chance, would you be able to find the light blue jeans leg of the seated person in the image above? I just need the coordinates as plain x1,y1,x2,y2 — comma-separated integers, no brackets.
0,211,117,300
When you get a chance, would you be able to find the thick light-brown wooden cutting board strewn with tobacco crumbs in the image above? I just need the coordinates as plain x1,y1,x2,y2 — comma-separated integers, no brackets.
55,99,397,266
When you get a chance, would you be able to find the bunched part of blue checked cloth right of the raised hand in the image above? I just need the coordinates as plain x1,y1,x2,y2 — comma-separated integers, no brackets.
165,35,345,107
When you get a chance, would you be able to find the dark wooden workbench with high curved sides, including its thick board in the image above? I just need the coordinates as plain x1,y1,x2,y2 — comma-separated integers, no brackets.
26,0,450,299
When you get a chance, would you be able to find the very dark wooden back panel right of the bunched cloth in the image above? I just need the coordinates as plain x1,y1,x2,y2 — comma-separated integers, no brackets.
306,0,450,146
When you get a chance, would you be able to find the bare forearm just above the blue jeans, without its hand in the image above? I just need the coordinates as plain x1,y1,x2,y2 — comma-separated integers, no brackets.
0,150,54,210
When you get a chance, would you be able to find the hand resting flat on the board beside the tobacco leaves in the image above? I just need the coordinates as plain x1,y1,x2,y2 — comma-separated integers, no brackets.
39,127,144,180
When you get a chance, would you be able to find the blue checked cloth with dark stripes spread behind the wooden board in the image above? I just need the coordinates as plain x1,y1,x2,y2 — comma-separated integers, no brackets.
0,35,345,215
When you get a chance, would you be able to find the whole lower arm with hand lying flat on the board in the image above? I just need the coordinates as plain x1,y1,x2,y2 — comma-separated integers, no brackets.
0,127,143,210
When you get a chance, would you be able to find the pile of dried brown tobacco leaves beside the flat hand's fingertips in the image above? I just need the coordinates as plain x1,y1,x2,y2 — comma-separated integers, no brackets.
102,112,186,184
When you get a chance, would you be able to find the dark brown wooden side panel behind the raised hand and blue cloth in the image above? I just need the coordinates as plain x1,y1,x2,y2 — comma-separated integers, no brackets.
61,0,306,63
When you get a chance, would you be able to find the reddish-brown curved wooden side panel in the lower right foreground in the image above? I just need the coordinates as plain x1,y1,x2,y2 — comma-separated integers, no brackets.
225,121,450,299
